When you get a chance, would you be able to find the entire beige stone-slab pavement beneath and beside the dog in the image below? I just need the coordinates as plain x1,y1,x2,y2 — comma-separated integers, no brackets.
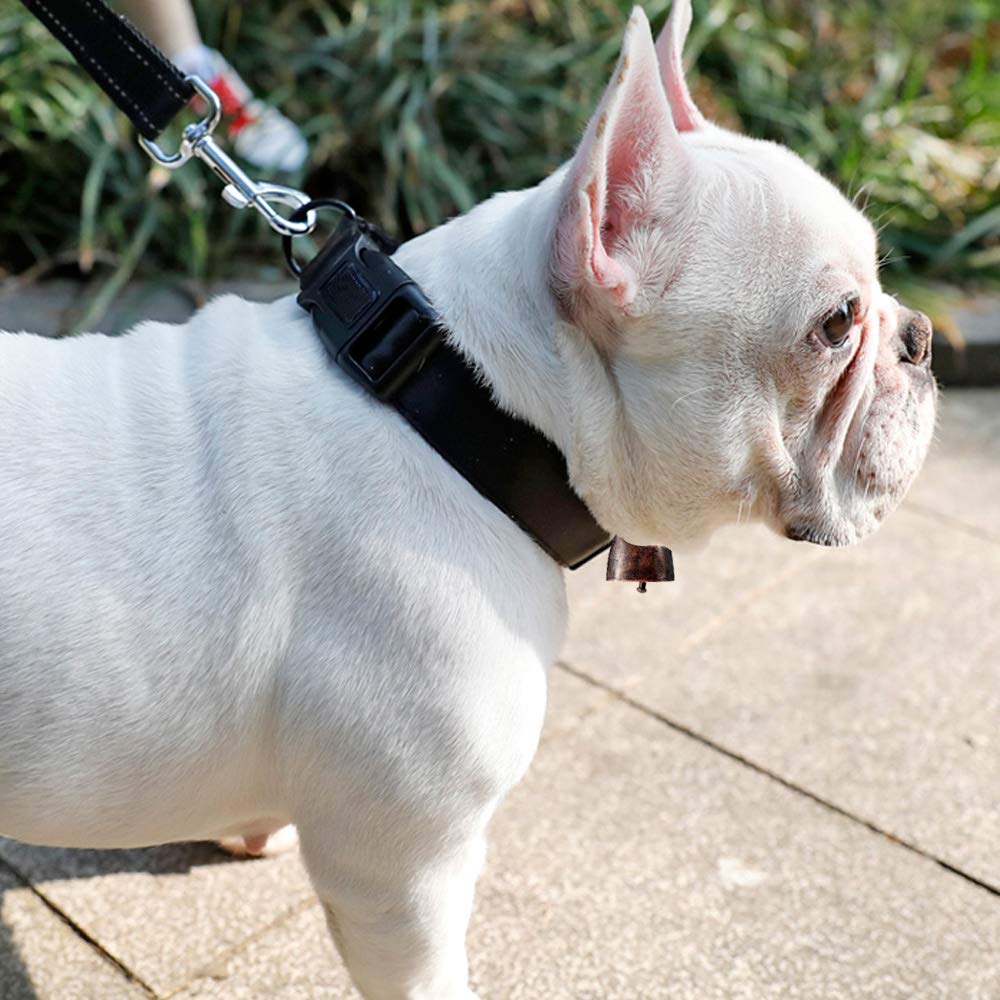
0,340,1000,1000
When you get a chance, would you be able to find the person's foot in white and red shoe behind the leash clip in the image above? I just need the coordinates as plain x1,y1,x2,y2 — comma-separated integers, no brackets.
176,46,309,172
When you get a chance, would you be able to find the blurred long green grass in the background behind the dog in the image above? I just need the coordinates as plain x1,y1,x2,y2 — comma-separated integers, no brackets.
0,0,1000,320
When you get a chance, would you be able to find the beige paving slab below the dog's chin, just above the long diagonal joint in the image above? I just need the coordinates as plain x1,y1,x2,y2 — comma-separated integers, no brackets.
571,510,1000,887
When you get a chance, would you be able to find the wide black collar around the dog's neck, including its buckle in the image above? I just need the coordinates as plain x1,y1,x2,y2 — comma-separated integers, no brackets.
286,202,611,569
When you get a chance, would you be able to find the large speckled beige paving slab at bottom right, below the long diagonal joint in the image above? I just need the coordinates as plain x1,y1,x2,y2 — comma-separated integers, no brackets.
470,681,1000,1000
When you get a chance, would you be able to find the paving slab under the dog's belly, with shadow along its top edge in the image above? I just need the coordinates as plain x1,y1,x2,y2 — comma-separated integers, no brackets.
0,839,312,994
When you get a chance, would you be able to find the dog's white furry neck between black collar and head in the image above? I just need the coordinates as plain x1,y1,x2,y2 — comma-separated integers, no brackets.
394,170,619,526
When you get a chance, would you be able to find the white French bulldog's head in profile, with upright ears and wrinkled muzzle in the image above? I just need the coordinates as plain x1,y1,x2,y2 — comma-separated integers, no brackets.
552,0,936,547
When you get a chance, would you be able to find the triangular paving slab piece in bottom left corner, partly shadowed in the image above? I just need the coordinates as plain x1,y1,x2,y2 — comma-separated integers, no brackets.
0,865,148,1000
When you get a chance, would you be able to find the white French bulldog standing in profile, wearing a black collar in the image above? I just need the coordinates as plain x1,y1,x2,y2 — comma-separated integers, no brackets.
0,0,935,1000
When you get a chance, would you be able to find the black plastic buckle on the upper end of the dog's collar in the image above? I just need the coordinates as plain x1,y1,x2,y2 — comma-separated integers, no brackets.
298,224,444,401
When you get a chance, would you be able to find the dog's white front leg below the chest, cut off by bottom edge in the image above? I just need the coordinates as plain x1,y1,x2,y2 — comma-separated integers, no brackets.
300,829,485,1000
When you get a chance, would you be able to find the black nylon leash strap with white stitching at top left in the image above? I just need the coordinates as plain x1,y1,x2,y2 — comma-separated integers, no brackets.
22,0,195,139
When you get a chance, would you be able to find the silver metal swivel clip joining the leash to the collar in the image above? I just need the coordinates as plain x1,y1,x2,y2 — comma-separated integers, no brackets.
139,76,316,236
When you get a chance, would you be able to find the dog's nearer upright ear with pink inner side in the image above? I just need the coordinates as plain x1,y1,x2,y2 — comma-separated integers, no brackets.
553,7,683,312
